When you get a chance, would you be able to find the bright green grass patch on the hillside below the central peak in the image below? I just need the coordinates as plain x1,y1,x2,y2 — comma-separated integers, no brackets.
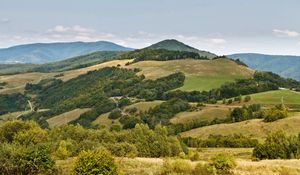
179,75,245,91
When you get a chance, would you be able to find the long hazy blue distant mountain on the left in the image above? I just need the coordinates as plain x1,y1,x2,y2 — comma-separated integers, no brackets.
0,41,133,64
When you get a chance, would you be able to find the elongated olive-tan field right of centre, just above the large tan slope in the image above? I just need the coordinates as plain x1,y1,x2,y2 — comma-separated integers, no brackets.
171,107,229,124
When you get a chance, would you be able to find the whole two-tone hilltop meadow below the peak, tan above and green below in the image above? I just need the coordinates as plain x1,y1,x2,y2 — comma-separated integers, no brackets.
126,59,253,91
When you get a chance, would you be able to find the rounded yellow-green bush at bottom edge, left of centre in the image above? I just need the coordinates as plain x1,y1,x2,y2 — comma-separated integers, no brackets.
73,150,118,175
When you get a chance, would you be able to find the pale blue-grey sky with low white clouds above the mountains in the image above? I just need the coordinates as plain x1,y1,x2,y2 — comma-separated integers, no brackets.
0,0,300,55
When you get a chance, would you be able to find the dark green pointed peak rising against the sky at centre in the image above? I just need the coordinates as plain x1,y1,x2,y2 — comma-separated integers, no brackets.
147,39,217,58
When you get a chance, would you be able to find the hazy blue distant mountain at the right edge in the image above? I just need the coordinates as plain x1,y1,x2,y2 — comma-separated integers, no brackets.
228,53,300,80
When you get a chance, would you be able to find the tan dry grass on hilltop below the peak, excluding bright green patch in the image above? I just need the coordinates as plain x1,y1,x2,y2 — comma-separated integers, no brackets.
126,59,254,79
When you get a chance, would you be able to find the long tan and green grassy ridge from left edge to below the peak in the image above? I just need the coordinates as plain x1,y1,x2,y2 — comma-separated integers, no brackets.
0,59,254,93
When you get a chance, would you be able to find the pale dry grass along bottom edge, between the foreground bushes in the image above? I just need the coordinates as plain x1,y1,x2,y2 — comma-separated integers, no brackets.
56,151,300,175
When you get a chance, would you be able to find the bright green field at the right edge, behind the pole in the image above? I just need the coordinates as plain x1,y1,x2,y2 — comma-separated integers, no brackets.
251,90,300,105
